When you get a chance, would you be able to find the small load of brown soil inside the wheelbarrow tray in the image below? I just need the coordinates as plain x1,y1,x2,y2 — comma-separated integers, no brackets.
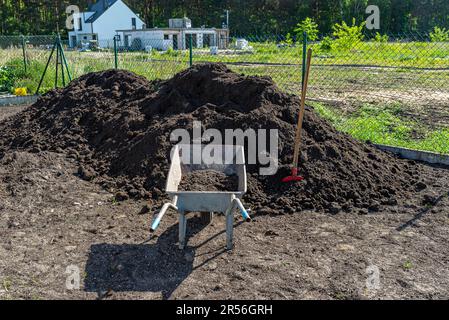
178,170,239,191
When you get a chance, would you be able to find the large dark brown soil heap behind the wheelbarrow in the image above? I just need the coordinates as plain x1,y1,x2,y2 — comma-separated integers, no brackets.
0,64,426,213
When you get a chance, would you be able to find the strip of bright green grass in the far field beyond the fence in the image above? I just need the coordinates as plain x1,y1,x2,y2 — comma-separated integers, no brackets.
148,42,449,68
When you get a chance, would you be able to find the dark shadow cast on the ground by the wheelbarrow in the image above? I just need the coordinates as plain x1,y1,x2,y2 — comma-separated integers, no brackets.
84,217,229,299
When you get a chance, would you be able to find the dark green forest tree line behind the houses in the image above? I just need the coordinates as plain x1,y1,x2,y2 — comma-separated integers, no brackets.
0,0,449,35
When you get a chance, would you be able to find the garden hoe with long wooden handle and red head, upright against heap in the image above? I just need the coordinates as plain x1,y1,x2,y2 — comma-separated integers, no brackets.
282,49,312,182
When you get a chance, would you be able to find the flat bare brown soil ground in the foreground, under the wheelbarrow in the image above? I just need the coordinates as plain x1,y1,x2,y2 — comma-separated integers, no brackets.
0,105,449,299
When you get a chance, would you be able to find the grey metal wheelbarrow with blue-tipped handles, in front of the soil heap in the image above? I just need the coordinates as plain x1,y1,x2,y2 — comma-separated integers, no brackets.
150,145,251,250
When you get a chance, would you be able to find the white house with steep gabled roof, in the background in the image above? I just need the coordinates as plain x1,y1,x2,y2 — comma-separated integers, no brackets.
69,0,145,47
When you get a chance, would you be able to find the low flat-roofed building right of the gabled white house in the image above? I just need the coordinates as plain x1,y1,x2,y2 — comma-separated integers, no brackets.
117,18,229,50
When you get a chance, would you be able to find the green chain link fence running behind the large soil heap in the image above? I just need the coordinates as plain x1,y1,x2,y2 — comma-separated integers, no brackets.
0,33,449,153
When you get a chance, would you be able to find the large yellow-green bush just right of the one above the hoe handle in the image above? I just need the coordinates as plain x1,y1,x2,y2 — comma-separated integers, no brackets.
332,18,366,50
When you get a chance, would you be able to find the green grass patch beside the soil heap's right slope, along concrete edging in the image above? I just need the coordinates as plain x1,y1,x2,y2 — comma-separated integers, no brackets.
310,102,449,154
